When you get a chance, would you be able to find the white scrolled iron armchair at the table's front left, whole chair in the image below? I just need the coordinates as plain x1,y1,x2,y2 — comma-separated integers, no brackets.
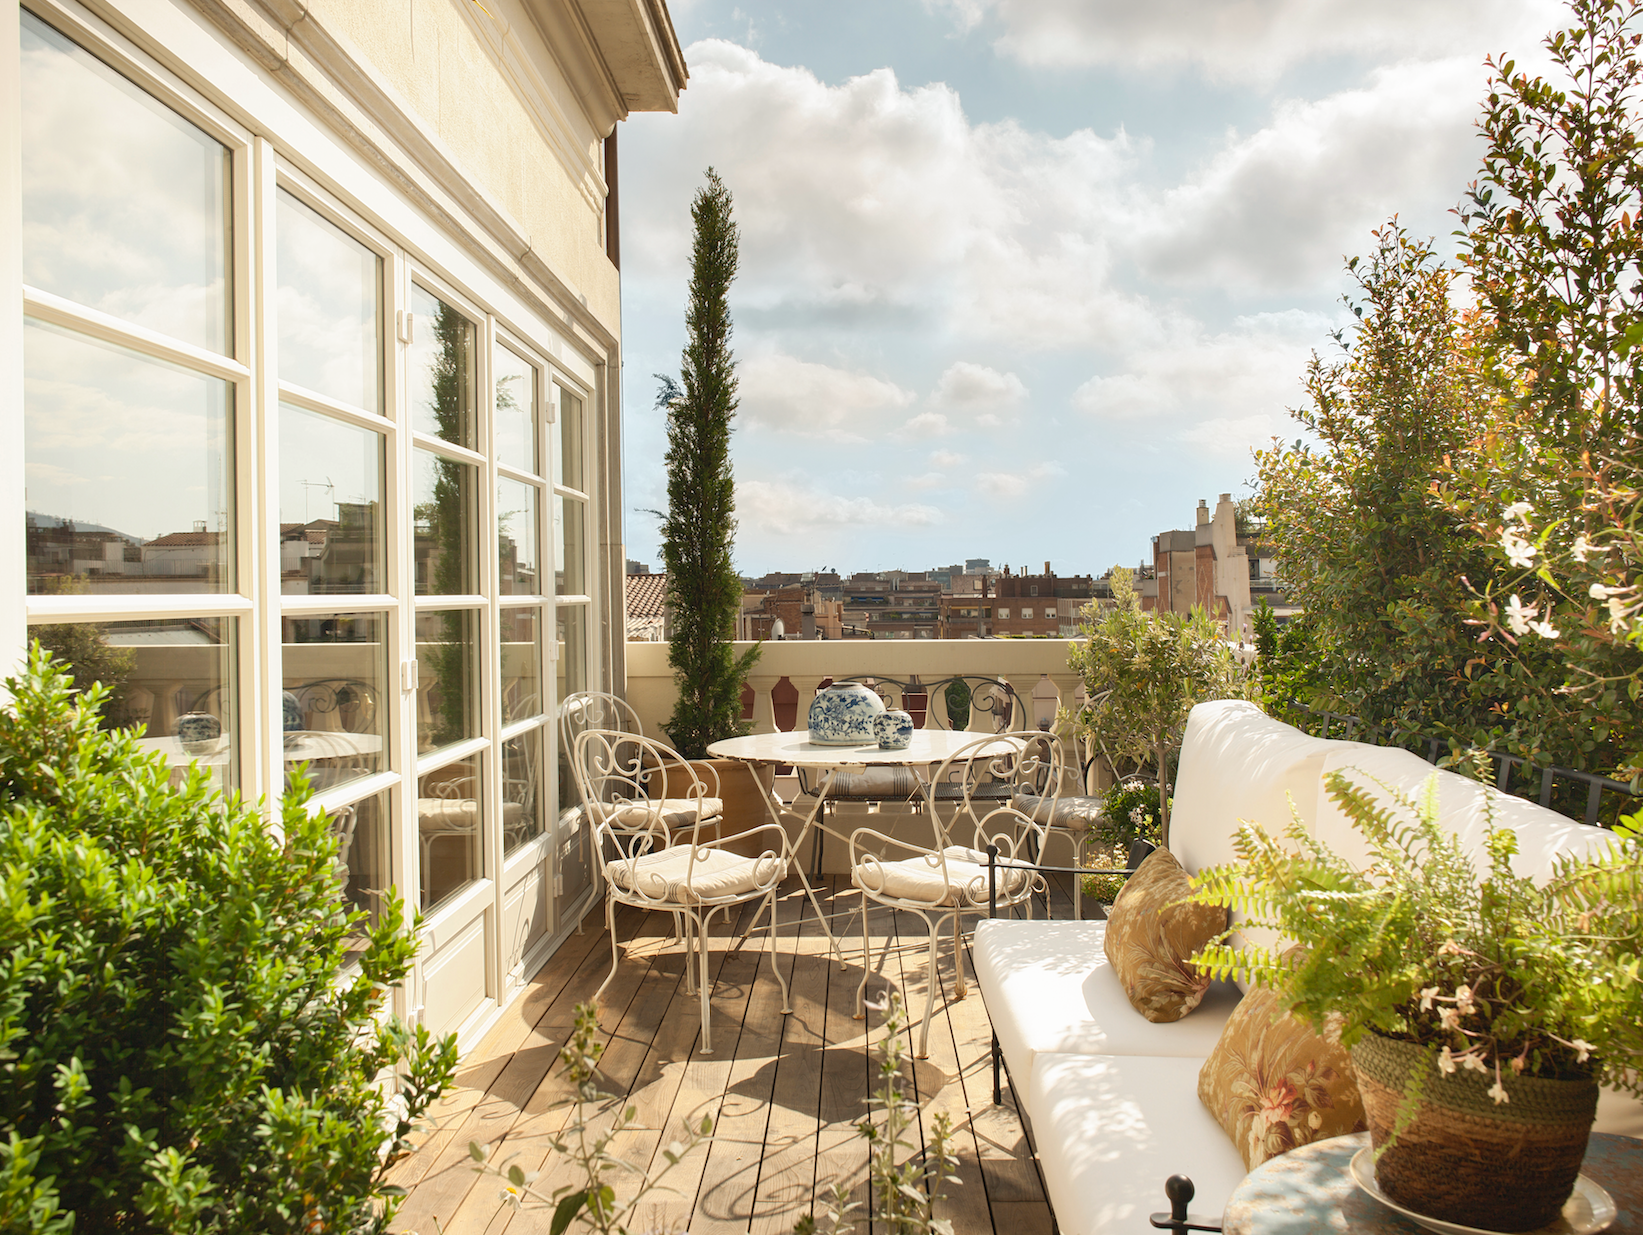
572,729,794,1054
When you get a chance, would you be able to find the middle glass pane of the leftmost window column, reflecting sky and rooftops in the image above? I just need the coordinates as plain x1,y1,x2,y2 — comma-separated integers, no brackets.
23,320,233,593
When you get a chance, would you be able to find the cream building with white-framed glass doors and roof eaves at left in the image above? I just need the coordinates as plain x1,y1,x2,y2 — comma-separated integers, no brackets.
0,0,687,1044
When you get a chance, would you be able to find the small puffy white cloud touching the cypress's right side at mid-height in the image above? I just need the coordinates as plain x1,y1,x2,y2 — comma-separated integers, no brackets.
738,351,915,442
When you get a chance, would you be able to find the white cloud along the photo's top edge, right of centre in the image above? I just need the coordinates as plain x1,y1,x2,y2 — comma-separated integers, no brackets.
925,0,1564,82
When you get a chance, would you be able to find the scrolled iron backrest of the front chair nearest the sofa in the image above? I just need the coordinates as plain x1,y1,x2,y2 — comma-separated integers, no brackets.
930,729,1065,861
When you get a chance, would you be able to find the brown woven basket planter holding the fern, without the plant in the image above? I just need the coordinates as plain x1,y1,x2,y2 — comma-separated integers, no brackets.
1352,1035,1597,1232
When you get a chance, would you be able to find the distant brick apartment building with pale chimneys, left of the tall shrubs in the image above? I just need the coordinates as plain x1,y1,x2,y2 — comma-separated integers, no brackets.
1139,493,1282,639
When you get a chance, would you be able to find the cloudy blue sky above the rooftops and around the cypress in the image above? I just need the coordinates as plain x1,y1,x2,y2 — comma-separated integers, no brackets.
619,0,1567,575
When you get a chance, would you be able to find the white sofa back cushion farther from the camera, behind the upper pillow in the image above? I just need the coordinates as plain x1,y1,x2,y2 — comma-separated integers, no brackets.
1170,700,1354,874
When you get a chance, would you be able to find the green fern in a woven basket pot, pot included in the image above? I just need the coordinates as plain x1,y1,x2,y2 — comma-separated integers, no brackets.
1193,774,1643,1232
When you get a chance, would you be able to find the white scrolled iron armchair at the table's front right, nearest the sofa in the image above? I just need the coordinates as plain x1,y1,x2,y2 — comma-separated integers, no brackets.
849,729,1061,1059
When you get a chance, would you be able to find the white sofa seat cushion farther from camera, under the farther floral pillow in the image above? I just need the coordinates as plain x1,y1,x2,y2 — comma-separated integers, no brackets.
971,918,1239,1086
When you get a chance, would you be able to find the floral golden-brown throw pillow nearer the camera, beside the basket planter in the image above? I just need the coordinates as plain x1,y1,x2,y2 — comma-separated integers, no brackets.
1198,987,1369,1171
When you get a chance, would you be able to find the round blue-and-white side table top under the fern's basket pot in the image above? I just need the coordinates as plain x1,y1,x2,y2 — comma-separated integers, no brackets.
1222,1132,1643,1235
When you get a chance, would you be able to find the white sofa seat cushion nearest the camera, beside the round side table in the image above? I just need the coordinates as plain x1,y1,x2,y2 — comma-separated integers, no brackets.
1027,1054,1244,1235
